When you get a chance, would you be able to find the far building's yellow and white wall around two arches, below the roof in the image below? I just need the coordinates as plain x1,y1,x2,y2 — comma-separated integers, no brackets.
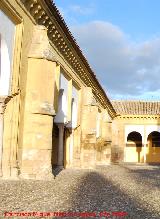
112,115,160,163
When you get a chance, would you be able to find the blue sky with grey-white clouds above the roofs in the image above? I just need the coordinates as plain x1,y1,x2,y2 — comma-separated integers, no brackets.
54,0,160,100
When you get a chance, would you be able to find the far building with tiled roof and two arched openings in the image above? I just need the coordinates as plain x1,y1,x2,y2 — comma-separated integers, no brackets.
112,101,160,163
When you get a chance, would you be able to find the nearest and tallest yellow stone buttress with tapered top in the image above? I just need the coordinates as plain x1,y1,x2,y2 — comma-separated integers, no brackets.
20,25,57,179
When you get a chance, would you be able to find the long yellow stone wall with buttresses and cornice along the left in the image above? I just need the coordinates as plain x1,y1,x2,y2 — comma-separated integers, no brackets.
0,0,115,179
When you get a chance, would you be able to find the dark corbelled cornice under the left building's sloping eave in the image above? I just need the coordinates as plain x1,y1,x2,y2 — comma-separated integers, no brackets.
20,0,116,117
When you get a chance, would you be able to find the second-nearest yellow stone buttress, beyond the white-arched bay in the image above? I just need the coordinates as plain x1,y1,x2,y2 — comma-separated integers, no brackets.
81,87,98,168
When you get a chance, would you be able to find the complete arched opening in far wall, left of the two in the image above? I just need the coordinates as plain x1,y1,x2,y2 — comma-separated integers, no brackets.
126,131,142,162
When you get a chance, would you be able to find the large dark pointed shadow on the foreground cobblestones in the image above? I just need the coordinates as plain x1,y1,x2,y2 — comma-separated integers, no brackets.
64,171,160,219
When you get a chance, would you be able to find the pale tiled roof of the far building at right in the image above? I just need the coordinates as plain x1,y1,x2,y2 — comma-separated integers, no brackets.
111,100,160,115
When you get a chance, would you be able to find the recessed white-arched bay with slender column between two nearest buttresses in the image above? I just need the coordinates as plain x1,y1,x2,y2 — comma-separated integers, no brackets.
52,77,79,172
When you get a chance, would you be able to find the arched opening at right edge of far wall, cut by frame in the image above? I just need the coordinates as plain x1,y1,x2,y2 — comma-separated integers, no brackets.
146,131,160,163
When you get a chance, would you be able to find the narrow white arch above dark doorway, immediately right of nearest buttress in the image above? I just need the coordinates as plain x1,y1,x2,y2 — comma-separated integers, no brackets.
52,72,69,172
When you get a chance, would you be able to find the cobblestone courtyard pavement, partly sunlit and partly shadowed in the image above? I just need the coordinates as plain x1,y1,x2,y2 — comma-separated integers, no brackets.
0,165,160,219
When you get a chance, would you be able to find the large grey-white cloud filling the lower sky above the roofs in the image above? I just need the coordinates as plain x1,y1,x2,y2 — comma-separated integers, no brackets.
71,21,160,99
